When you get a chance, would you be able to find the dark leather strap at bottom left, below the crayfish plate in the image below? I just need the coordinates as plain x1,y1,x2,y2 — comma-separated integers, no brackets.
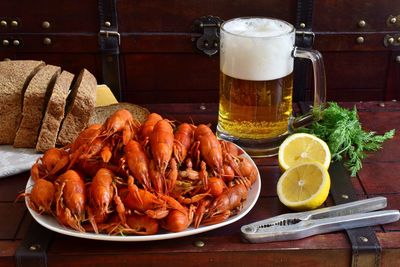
15,221,53,267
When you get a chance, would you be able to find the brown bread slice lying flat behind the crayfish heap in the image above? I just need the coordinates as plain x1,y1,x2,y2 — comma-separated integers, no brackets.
89,102,150,124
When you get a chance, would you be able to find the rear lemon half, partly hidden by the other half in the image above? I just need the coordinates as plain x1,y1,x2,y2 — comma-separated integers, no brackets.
278,133,331,170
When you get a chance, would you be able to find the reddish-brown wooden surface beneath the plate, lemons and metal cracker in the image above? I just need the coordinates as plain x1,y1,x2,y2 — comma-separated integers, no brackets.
0,102,400,267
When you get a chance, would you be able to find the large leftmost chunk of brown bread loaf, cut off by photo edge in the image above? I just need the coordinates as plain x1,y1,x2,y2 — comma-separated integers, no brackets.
0,60,45,144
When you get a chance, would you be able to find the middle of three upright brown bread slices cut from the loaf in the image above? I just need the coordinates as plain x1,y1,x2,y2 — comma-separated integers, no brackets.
36,70,74,152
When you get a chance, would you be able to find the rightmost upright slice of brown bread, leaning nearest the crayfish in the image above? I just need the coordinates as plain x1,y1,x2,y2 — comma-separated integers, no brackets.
57,69,97,146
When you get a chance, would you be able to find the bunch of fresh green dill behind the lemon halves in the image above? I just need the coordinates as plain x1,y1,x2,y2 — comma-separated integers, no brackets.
299,102,395,176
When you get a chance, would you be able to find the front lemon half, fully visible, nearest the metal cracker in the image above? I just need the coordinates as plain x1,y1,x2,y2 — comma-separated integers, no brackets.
277,162,331,211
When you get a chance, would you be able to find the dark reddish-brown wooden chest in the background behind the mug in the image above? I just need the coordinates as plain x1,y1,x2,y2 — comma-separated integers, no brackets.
0,0,400,103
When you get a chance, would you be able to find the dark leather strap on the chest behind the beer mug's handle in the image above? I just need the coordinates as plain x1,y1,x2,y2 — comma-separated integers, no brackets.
293,0,314,102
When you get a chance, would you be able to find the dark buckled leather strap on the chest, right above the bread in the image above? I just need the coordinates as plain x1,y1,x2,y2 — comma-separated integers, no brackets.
98,0,122,101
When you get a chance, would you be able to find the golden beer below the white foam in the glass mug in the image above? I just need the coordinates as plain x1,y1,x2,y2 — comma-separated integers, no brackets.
218,71,293,139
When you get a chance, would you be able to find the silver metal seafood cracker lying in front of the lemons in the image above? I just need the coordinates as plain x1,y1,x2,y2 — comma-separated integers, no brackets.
241,197,400,243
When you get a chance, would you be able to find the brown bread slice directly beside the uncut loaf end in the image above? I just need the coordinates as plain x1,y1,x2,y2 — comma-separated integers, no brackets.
14,65,61,147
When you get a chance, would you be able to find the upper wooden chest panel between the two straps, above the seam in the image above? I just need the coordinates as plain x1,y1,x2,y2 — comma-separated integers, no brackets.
118,0,296,33
